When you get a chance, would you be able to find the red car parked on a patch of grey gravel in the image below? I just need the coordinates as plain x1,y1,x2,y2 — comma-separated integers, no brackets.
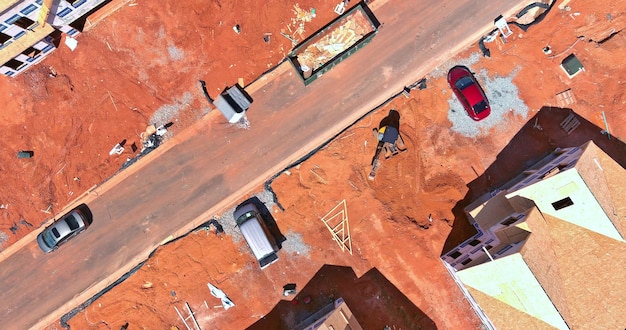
448,66,491,121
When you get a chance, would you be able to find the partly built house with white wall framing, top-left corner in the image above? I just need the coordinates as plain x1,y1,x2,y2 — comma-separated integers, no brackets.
0,0,106,77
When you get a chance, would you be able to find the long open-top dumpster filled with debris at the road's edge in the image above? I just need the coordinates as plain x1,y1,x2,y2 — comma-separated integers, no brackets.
287,1,380,85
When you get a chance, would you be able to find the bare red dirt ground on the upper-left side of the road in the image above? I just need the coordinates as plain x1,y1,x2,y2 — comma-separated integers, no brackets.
0,0,336,249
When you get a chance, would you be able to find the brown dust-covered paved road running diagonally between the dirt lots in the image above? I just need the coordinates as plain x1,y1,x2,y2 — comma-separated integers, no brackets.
0,0,529,329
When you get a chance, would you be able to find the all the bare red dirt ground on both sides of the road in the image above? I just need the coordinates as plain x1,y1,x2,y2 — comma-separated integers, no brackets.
0,0,626,329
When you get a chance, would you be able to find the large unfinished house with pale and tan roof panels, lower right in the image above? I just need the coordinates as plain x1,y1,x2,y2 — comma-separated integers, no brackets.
442,141,626,329
